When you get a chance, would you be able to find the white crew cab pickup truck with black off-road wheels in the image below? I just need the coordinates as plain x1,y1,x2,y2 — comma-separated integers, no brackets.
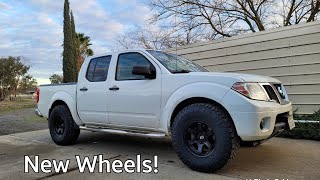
36,50,295,172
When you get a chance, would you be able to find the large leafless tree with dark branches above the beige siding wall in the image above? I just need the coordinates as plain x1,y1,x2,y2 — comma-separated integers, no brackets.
150,0,320,39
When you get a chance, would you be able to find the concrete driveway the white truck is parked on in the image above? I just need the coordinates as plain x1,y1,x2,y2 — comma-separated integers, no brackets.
0,130,320,180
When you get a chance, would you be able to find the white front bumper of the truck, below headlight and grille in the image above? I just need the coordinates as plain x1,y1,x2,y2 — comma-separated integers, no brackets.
222,91,294,141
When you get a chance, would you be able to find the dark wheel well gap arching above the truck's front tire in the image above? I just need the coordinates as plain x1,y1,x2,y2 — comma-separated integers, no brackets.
170,97,235,129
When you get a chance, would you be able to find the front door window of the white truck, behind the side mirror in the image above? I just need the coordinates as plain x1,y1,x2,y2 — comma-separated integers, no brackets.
116,53,153,81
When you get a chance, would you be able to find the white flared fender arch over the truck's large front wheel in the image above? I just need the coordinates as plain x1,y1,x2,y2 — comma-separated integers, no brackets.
159,82,230,134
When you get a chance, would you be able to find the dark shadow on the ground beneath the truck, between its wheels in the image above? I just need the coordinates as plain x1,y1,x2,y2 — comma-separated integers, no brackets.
76,132,178,162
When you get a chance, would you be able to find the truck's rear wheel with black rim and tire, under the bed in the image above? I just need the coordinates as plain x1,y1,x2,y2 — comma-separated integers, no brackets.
49,105,80,146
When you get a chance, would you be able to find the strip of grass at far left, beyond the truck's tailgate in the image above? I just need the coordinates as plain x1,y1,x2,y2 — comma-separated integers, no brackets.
0,98,37,114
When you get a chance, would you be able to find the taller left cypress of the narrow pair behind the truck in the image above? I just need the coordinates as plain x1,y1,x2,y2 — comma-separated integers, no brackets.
62,0,76,82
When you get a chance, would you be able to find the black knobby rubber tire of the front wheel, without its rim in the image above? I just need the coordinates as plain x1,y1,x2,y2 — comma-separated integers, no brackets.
171,103,240,172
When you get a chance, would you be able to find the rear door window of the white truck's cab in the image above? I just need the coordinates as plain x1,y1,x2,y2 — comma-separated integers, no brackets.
86,56,111,82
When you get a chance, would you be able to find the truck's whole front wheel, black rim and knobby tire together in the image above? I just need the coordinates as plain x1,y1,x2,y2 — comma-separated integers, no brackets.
172,103,240,172
